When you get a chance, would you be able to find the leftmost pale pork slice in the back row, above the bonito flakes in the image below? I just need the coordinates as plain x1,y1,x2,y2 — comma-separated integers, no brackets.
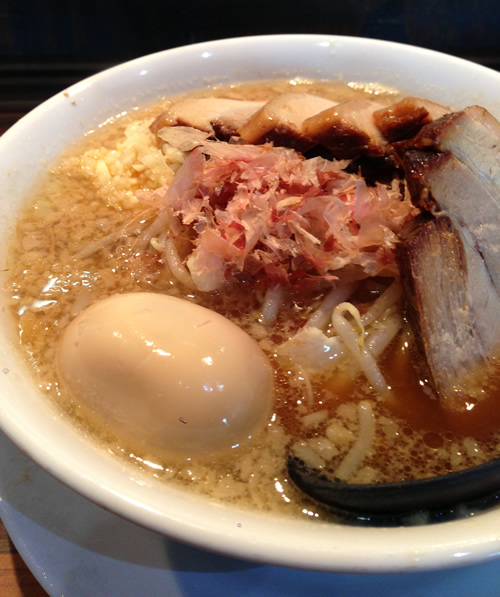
150,97,265,140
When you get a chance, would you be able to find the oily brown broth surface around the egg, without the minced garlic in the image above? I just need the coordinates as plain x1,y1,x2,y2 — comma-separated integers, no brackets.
9,81,500,518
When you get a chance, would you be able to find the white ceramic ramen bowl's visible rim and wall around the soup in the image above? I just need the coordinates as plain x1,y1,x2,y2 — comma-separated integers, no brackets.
0,35,500,572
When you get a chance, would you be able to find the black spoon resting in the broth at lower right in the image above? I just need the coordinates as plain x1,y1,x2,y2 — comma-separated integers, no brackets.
288,456,500,517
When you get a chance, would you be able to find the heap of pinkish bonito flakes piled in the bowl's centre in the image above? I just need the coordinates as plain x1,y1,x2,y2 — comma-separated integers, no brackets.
146,141,418,291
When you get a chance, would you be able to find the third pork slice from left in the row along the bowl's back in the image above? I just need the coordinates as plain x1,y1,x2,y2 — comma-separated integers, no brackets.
303,98,388,159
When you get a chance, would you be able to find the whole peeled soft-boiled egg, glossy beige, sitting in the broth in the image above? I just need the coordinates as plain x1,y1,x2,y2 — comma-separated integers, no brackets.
57,293,273,454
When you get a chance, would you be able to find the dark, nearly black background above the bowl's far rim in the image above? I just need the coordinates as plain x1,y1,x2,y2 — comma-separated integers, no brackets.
0,0,500,128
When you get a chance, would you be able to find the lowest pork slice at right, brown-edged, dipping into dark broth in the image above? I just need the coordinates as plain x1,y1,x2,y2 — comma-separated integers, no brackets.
397,216,500,410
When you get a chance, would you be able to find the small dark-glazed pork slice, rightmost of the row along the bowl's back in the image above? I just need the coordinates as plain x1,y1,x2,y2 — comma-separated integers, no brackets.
373,97,450,143
